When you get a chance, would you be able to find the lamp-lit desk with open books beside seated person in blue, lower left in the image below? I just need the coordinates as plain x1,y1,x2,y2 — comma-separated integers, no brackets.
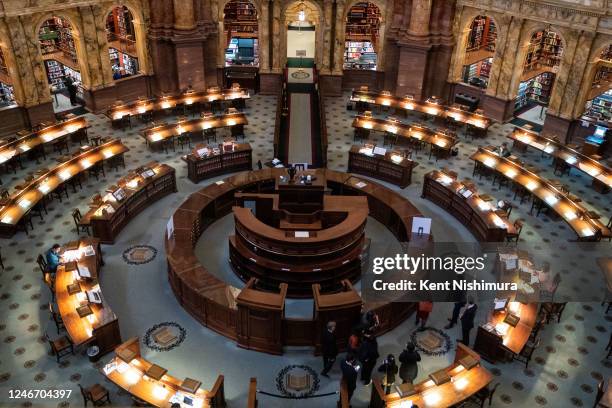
55,238,121,355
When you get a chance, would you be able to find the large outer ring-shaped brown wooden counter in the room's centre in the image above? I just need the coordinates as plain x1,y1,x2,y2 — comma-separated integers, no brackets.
165,169,428,354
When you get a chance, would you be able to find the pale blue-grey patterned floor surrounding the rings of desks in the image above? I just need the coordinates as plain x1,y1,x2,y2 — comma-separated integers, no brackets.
0,95,612,408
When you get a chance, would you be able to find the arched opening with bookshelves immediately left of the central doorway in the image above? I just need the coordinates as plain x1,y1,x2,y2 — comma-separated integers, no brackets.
223,0,259,67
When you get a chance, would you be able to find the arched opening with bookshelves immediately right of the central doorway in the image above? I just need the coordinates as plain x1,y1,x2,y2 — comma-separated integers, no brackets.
344,2,382,70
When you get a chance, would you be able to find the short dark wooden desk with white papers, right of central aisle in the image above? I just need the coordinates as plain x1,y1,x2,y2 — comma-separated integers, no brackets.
348,145,418,188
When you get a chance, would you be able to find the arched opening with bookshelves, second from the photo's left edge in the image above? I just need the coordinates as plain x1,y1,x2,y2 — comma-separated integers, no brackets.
38,16,83,111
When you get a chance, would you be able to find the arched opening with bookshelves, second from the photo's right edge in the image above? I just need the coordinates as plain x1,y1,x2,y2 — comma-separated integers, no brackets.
515,29,563,118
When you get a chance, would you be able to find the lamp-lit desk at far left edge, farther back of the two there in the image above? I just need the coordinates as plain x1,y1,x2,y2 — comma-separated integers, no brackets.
0,116,89,164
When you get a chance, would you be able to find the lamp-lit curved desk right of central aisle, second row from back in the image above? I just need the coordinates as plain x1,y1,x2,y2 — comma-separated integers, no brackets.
352,115,459,156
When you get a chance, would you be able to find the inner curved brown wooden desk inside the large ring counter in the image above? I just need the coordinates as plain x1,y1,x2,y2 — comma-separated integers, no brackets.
229,194,368,297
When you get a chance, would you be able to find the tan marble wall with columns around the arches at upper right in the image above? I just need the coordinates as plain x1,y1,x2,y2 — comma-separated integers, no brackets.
448,0,612,126
